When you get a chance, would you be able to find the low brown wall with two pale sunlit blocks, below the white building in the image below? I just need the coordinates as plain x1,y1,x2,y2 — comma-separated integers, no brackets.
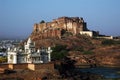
0,63,54,70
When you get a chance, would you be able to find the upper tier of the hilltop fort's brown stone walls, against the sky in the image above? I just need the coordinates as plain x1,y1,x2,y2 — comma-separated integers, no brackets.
34,17,86,32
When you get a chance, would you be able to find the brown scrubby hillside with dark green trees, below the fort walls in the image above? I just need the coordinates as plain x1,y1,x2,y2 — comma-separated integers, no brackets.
30,34,120,66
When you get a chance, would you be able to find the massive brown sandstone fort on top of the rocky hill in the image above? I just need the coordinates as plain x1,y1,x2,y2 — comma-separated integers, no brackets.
32,17,88,39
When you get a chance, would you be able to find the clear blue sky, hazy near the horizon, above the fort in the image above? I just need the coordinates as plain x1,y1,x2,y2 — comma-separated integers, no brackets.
0,0,120,38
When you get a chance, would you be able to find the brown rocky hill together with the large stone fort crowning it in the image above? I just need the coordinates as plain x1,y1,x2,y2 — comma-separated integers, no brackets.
30,17,120,66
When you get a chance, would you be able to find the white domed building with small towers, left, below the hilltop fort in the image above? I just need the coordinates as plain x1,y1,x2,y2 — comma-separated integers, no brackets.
8,38,52,64
